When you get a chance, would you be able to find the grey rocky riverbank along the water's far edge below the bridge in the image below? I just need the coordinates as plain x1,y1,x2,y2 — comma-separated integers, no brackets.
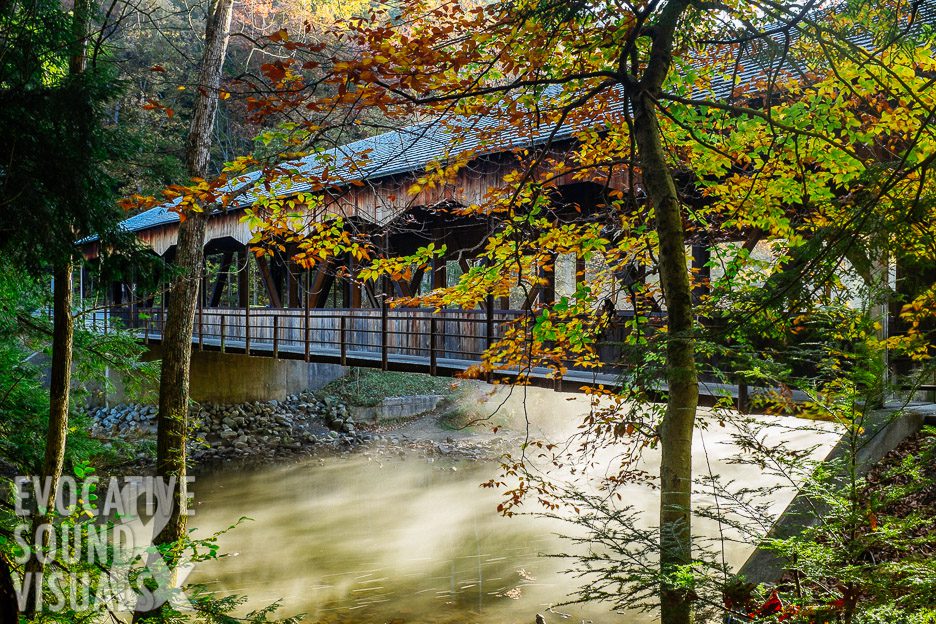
89,392,512,463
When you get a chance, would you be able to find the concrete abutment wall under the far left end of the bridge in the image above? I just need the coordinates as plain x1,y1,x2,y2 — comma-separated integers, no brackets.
108,345,347,403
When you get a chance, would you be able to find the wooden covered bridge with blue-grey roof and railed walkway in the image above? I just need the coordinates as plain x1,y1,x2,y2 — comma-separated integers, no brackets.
83,118,721,394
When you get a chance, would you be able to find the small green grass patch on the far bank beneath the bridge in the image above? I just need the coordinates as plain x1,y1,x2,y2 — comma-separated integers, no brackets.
316,368,457,407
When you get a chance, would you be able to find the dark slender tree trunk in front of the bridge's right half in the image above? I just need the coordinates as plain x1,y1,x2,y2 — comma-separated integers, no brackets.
632,0,699,624
